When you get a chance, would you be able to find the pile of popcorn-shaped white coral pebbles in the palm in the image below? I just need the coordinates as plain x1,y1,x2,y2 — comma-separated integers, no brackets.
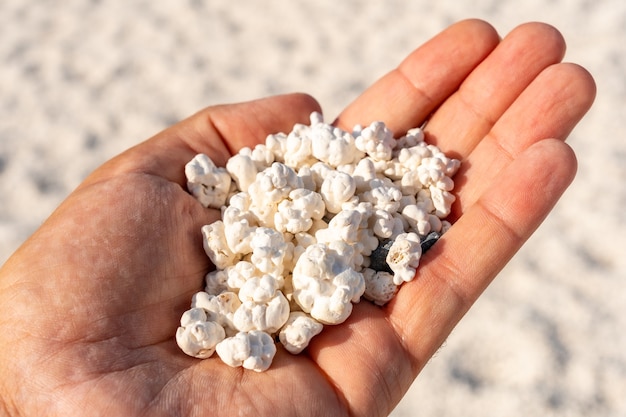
176,113,460,371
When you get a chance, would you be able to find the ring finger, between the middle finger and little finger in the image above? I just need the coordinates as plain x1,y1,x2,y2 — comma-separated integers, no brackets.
451,64,595,220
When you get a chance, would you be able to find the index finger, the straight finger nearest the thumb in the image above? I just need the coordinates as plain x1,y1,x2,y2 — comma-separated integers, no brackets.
335,20,499,134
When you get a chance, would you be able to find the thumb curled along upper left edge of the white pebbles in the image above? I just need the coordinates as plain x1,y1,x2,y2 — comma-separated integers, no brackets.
82,94,321,185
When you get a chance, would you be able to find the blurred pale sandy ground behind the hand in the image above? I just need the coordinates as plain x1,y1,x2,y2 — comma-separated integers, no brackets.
0,0,626,417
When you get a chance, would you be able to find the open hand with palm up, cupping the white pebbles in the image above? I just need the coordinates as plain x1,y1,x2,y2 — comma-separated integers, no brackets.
0,20,595,417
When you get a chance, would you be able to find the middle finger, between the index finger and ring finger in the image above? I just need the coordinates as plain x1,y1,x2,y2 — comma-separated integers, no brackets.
425,23,565,158
